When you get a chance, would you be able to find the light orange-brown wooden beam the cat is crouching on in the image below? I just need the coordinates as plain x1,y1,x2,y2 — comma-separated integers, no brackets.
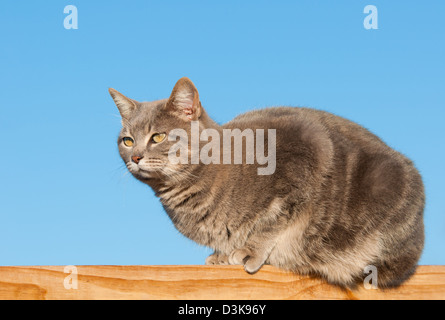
0,266,445,300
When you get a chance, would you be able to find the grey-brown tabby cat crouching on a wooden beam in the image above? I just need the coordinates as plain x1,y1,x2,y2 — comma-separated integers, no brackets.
109,78,425,288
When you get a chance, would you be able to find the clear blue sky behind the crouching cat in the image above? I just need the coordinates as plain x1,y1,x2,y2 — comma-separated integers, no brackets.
0,0,445,265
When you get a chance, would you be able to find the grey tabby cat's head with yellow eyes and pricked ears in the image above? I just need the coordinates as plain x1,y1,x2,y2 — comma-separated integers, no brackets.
109,78,211,182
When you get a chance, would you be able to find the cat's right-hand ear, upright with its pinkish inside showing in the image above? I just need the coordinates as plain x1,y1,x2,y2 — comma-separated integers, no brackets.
166,77,202,121
